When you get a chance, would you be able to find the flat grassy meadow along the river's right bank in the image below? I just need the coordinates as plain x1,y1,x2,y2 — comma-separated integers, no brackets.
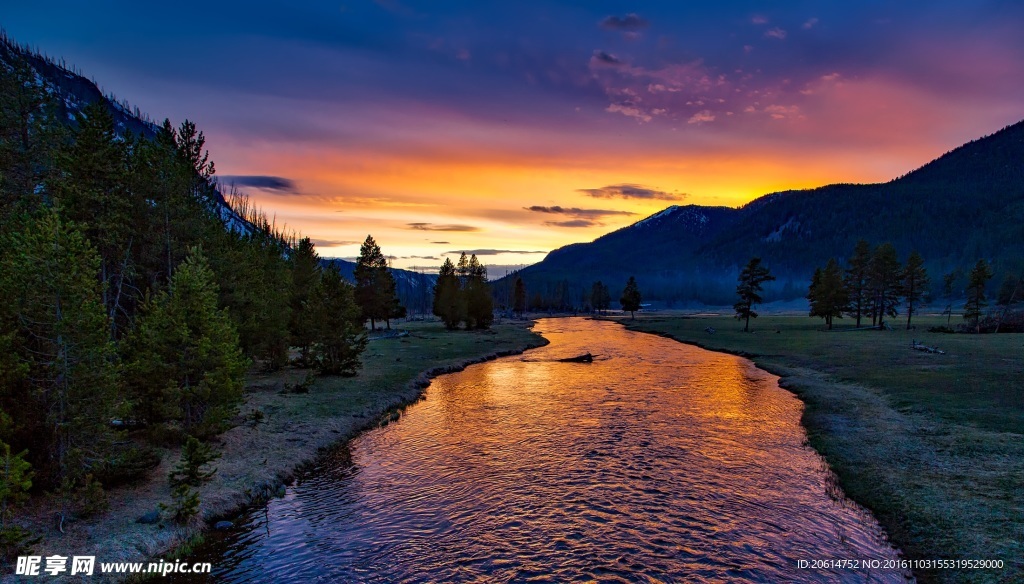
624,314,1024,582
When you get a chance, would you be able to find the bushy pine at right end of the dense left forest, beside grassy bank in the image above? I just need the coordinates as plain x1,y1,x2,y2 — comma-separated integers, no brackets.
310,269,367,375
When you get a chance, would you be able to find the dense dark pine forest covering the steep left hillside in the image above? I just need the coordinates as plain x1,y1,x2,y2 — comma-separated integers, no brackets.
0,30,366,540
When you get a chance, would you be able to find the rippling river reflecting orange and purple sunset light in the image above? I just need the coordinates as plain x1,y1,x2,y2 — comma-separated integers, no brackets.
189,318,904,582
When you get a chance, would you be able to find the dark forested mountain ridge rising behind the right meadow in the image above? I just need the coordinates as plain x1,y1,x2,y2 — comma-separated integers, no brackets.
512,122,1024,305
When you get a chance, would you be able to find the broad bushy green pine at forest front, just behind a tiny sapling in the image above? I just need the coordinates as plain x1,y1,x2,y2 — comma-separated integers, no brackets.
125,249,247,436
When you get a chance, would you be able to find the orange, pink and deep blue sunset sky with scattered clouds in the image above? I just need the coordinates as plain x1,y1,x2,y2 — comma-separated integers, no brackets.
6,0,1024,268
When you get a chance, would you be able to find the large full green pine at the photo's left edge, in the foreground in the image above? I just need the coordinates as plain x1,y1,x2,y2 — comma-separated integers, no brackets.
0,209,122,491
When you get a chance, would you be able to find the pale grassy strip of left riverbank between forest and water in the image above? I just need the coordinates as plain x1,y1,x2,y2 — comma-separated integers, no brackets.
4,321,547,581
